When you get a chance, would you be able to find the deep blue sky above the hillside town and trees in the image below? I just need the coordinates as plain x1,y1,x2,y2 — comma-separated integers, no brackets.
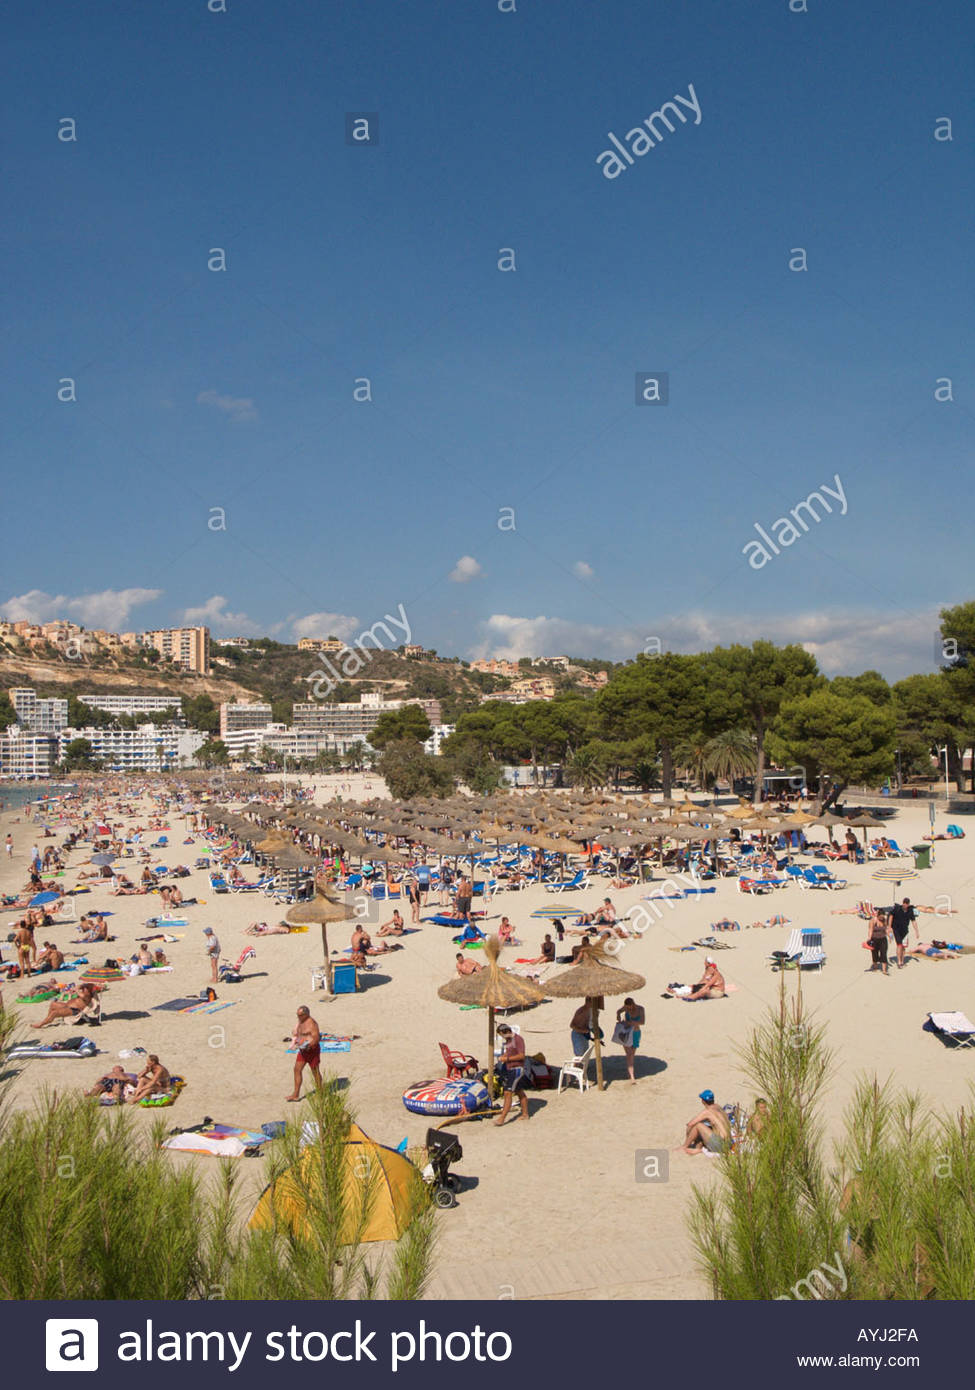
0,0,975,677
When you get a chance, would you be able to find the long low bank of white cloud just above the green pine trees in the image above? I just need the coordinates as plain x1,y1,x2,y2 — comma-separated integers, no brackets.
470,609,939,680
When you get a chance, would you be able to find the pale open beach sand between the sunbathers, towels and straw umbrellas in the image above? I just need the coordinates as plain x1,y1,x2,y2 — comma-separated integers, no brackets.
0,774,975,1300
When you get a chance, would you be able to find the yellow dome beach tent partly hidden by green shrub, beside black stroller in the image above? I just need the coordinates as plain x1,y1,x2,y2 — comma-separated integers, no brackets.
249,1125,420,1244
